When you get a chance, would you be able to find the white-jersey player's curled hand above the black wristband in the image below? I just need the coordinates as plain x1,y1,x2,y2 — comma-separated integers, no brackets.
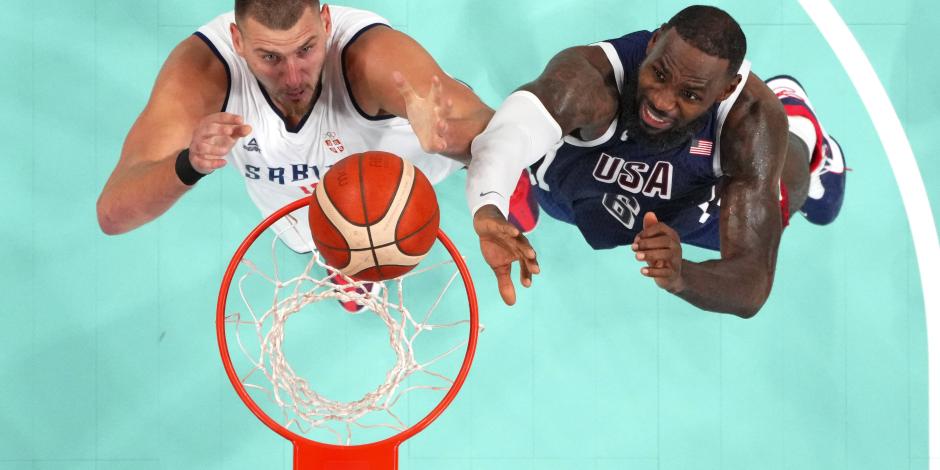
189,113,251,175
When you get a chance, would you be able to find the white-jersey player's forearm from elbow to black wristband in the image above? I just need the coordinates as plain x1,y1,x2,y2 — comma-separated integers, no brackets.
97,155,190,235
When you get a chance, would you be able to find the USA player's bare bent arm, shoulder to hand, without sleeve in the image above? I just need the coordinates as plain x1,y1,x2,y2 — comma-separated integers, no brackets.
633,74,788,318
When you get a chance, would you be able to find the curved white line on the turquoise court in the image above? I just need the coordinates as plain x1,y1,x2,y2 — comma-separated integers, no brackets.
798,0,940,464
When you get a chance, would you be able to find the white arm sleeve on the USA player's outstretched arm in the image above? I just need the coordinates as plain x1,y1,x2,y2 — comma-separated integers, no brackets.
467,91,562,217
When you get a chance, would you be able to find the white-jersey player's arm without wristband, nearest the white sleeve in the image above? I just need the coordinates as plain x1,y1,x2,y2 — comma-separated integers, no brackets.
346,26,493,163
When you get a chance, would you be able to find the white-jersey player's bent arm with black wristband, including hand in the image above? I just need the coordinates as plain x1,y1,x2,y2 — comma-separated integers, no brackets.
97,36,250,235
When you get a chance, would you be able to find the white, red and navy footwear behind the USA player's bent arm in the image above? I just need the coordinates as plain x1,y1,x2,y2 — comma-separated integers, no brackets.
767,75,846,225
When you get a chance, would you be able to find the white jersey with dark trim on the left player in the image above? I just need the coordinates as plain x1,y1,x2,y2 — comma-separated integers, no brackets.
196,5,461,252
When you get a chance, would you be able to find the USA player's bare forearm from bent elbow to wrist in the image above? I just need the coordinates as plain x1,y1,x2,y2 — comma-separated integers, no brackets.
673,260,773,318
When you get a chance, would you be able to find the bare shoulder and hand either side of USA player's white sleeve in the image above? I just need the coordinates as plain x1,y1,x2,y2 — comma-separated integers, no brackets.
473,46,619,305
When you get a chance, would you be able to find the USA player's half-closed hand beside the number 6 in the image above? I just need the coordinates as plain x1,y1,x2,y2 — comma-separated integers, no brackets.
632,212,682,292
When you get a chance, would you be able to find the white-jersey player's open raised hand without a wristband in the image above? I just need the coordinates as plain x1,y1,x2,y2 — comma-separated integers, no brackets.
392,72,454,153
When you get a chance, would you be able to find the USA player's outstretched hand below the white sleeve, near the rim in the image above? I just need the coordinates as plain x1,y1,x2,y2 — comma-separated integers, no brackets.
473,205,539,305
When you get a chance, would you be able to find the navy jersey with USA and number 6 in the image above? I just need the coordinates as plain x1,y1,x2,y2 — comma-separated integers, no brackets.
531,31,750,250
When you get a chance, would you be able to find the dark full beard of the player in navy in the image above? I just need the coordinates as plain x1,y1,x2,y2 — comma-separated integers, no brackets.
619,74,709,153
